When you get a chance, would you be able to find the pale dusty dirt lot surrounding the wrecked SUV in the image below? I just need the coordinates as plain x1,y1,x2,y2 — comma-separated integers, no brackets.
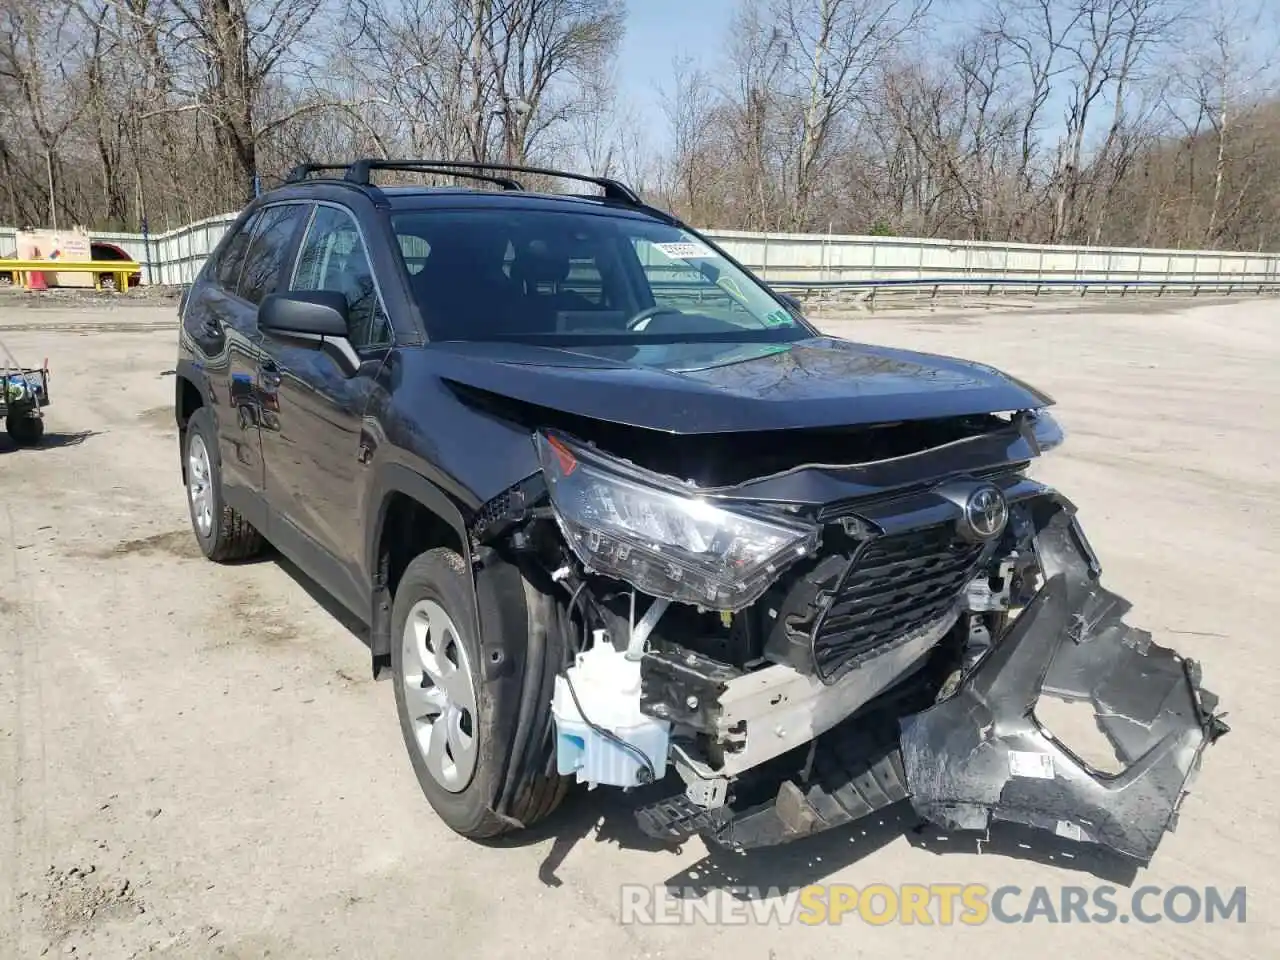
0,293,1280,960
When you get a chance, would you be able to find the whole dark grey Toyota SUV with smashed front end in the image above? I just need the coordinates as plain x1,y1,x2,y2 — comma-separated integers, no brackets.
175,160,1226,861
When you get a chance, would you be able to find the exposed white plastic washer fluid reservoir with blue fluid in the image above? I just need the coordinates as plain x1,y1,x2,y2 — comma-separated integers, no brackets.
552,630,671,787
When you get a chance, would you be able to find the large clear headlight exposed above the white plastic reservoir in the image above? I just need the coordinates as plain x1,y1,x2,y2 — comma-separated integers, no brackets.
535,433,818,611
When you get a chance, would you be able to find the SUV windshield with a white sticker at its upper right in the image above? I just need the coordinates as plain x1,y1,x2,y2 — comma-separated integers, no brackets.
392,209,809,344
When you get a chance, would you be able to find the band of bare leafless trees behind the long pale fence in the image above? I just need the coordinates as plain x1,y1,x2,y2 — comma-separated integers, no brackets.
0,0,1280,256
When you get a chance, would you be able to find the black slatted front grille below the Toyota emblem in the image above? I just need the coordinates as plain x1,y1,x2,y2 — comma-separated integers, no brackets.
813,525,983,681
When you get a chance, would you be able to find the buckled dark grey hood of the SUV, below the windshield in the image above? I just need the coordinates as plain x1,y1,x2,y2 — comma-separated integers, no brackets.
428,337,1053,434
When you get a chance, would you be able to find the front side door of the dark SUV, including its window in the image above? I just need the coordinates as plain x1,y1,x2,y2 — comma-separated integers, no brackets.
260,202,393,613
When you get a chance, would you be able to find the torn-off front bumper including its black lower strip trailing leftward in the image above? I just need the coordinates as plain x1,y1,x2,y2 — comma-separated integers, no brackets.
640,499,1228,863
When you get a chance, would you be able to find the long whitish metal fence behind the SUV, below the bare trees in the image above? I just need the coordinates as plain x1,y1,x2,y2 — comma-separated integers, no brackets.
0,214,1280,293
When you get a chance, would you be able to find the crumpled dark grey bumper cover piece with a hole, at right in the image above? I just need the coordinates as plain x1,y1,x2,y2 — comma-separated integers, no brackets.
901,511,1228,863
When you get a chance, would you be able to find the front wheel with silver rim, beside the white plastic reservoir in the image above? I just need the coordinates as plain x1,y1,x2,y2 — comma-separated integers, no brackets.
392,548,568,840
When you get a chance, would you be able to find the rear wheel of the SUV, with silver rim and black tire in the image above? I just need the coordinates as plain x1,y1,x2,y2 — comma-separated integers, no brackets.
183,407,262,563
